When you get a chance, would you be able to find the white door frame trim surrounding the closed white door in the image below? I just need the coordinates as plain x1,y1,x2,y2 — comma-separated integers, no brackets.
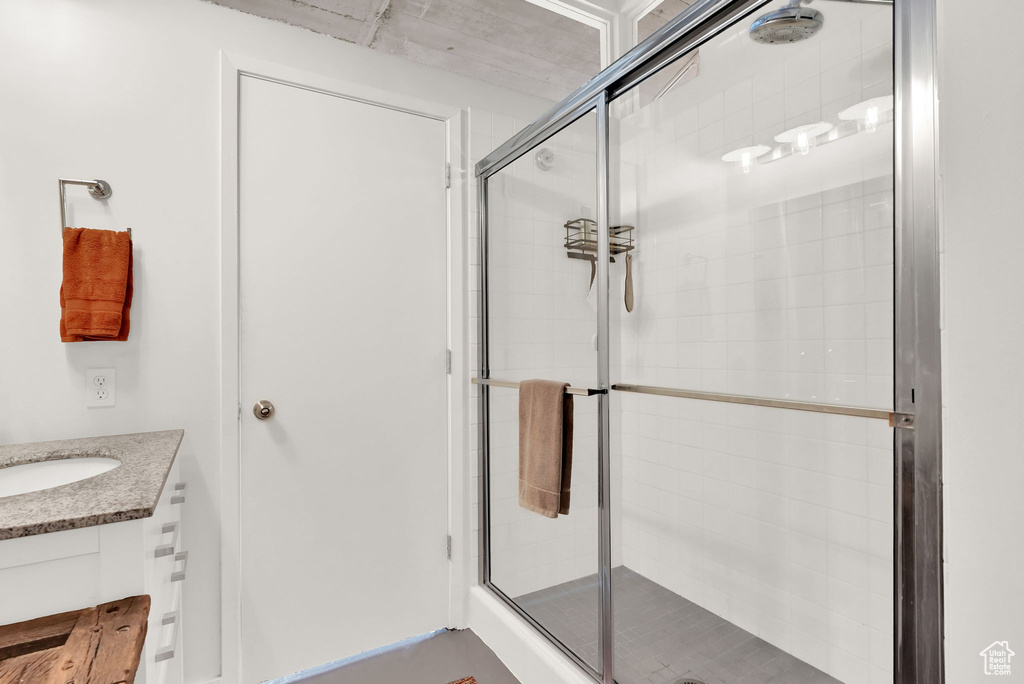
220,51,471,684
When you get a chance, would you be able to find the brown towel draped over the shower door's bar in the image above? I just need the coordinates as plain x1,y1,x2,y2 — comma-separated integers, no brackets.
519,380,572,518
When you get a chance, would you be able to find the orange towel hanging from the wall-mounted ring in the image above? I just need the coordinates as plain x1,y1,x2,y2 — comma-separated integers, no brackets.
60,228,132,342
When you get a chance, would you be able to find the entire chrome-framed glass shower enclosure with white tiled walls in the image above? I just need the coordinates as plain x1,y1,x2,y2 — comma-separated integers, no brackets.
475,0,942,684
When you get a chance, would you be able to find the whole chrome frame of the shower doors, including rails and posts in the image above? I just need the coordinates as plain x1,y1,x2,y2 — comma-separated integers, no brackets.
475,0,944,684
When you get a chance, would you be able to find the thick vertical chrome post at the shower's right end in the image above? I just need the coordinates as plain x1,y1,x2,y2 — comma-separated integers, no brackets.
893,0,945,684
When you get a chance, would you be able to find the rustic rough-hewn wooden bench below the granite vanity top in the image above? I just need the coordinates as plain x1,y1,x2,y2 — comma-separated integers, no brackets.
0,596,150,684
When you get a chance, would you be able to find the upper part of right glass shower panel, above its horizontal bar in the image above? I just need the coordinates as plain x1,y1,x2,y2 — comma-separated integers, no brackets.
612,3,893,407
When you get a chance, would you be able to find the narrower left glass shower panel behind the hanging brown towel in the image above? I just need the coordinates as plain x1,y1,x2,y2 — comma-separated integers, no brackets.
486,113,599,670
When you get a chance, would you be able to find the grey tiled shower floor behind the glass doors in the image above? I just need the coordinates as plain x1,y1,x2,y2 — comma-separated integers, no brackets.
515,567,840,684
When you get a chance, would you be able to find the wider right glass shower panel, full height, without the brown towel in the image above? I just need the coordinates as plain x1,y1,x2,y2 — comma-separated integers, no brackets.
610,2,894,684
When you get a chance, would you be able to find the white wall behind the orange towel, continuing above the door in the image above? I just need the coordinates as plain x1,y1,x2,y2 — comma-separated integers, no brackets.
0,0,550,682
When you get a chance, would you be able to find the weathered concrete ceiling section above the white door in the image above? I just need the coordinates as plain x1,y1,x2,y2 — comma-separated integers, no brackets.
210,0,606,101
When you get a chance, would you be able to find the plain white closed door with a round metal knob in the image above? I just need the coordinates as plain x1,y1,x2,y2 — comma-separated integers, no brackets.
241,77,447,684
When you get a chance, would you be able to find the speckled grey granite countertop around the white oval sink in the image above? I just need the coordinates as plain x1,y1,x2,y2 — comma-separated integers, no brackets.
0,430,184,540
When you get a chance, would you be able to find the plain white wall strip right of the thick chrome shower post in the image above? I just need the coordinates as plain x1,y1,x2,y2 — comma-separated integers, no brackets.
938,0,1024,684
